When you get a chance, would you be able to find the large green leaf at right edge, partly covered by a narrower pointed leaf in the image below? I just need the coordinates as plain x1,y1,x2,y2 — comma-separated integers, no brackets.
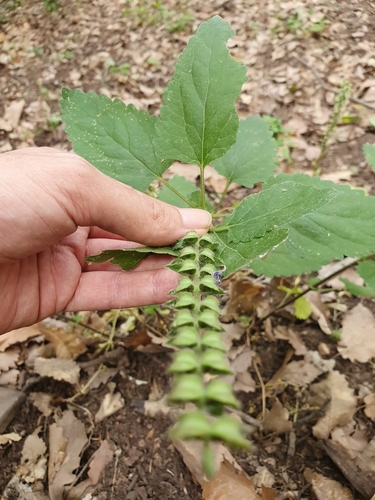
252,174,375,276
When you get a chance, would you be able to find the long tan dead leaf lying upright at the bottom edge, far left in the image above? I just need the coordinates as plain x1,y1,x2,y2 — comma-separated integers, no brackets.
48,410,87,500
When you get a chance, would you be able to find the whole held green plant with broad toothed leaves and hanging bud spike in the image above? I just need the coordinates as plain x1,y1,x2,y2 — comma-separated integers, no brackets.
61,16,375,474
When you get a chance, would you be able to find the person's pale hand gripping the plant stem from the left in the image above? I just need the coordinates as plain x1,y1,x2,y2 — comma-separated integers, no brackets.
0,148,211,333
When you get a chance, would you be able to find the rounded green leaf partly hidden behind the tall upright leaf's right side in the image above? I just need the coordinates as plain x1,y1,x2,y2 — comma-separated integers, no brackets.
211,116,277,188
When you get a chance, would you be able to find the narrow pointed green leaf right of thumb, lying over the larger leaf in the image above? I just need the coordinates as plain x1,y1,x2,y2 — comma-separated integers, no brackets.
215,182,339,244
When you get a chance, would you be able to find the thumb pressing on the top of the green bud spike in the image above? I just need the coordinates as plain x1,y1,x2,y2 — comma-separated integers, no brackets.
74,160,212,246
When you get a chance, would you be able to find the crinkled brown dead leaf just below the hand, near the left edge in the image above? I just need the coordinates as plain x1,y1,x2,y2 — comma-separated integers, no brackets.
41,326,87,359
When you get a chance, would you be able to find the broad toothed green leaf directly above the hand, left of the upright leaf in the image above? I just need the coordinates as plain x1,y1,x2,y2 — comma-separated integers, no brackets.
60,88,170,191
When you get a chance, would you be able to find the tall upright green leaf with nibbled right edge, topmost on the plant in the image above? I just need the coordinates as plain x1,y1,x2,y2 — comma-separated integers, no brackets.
155,16,246,167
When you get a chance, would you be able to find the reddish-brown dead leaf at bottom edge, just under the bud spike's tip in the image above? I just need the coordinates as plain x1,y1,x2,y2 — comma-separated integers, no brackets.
202,458,261,500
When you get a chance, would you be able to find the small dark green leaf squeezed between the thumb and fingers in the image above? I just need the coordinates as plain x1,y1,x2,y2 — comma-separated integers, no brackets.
86,247,178,271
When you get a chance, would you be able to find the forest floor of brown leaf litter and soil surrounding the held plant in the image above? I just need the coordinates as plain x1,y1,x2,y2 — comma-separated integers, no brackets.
0,0,375,500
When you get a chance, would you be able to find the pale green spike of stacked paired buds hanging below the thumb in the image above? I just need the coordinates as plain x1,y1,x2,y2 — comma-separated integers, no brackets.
168,231,249,476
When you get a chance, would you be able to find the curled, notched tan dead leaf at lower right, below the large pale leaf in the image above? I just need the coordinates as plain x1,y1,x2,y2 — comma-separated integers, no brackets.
310,370,357,439
